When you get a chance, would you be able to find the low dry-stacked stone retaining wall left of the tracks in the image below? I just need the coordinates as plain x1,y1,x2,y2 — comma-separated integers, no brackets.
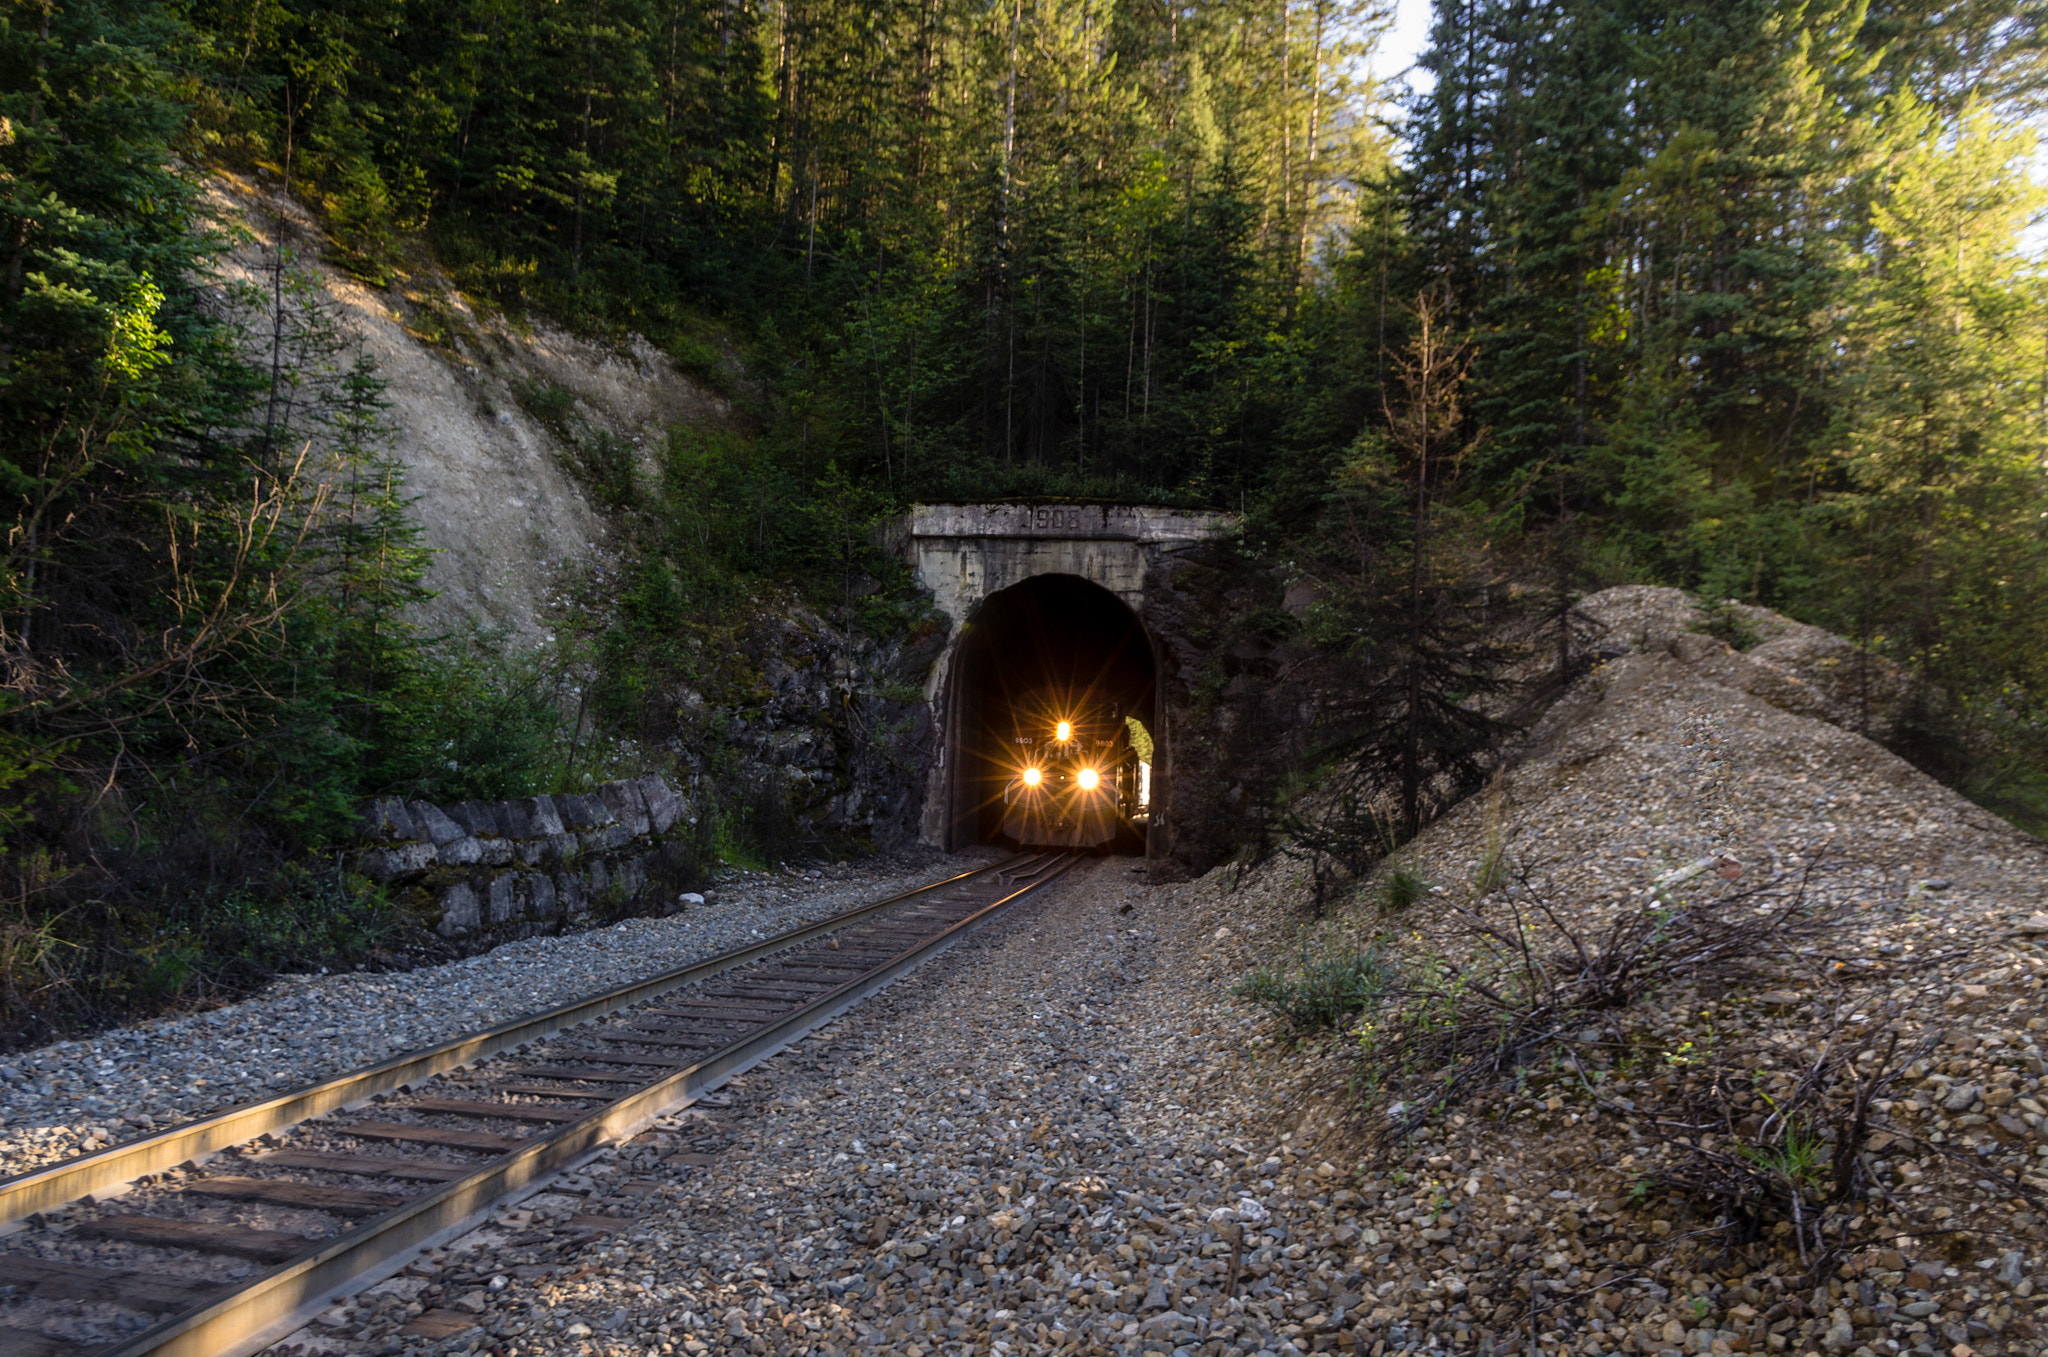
356,776,696,942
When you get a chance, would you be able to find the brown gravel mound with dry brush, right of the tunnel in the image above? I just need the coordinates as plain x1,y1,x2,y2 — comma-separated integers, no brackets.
1182,589,2048,1355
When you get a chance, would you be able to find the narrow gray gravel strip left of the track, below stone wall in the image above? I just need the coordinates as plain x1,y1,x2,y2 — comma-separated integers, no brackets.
0,856,995,1175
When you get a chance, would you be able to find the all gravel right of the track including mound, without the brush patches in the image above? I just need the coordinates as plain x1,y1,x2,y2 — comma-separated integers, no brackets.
264,596,2048,1357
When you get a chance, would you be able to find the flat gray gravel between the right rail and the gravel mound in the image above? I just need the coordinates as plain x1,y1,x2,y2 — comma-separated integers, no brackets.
268,860,1327,1355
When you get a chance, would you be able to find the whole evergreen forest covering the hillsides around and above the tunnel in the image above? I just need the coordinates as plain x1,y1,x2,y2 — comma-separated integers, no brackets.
0,0,2048,1032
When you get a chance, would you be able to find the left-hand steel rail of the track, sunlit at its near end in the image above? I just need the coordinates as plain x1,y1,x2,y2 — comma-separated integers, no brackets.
0,858,1018,1222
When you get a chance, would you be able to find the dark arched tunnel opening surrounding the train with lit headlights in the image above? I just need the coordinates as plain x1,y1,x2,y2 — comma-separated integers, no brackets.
946,575,1165,853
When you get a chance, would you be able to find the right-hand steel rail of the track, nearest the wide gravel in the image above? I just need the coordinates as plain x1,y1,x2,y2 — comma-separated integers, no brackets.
98,856,1075,1357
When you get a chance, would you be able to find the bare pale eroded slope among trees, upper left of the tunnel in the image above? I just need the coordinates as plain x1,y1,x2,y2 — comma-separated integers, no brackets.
211,174,731,647
